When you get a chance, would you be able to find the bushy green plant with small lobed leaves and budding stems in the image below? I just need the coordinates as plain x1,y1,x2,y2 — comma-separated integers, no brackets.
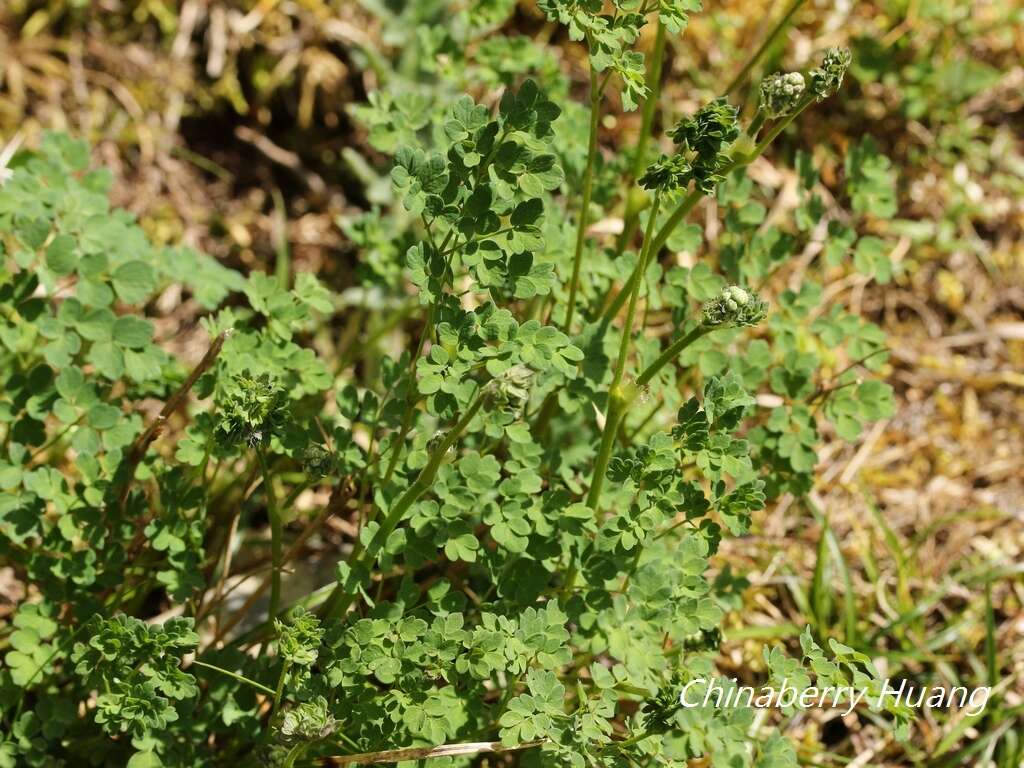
0,1,906,766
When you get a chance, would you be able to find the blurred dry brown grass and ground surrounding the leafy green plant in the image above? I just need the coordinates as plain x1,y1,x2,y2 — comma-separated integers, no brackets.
0,0,1024,766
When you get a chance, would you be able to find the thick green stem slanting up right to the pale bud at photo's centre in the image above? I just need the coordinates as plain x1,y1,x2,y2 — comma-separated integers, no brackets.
324,390,489,618
